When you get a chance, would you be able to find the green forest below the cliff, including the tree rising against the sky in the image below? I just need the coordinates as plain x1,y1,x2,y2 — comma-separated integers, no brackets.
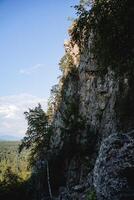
0,104,51,200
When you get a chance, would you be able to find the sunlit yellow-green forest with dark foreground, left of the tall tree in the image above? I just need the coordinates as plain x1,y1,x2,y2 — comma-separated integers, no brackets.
0,142,31,200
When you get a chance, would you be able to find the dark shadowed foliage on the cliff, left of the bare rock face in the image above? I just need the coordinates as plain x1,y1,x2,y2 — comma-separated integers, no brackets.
60,96,86,157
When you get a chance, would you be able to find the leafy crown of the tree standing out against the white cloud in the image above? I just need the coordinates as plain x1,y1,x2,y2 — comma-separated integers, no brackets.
19,104,52,165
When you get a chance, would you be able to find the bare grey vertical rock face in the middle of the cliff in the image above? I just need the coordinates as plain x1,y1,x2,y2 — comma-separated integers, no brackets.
79,52,119,137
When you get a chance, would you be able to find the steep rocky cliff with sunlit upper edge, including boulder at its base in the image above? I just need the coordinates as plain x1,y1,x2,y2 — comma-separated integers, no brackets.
44,1,134,200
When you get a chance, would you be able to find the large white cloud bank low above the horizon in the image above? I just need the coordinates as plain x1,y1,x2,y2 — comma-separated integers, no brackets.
0,94,47,136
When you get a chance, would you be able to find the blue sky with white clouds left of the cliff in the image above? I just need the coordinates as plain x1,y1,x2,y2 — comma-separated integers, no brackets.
0,0,79,136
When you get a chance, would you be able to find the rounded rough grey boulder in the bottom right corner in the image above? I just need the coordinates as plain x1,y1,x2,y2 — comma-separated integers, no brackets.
94,131,134,200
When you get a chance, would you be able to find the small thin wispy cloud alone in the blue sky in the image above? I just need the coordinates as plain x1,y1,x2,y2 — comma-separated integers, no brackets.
19,64,44,75
